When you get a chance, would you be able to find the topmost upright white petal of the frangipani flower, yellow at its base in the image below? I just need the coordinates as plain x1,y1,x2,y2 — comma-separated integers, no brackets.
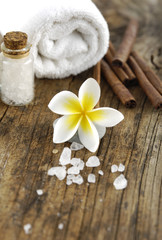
79,78,100,111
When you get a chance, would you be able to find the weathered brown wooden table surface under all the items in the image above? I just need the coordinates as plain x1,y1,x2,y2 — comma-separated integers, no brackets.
0,0,162,240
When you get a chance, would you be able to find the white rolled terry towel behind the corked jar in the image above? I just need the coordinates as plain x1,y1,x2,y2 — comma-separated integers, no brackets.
0,0,109,78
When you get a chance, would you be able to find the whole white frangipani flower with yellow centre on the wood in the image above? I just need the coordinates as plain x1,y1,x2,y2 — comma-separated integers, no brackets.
48,78,124,152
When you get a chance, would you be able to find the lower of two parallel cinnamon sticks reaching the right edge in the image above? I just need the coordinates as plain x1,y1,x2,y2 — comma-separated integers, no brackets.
129,56,162,109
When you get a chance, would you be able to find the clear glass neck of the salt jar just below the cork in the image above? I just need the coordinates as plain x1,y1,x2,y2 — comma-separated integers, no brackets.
1,43,31,59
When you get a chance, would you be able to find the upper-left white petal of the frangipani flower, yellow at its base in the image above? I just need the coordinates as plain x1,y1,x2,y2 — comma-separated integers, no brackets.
48,91,82,115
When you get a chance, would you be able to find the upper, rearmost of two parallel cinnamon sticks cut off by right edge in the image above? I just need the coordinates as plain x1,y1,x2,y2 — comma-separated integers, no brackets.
131,51,162,94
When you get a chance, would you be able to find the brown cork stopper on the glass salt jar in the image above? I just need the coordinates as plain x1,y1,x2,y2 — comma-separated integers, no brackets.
4,32,28,50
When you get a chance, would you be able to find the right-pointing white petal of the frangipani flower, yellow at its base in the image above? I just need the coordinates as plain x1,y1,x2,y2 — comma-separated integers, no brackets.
87,107,124,127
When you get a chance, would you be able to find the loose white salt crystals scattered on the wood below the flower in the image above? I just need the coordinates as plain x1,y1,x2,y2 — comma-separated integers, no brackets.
48,145,127,190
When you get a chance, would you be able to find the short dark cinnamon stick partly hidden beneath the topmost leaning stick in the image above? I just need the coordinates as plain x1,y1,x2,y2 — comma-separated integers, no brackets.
104,51,129,85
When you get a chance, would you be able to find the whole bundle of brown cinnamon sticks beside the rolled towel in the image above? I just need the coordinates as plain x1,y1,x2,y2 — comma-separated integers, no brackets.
94,19,162,109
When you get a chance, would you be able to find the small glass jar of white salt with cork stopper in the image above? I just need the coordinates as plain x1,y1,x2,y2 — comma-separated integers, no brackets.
1,32,34,106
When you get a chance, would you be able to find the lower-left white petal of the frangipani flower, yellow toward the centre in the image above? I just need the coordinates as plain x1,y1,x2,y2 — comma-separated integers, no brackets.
53,114,82,143
